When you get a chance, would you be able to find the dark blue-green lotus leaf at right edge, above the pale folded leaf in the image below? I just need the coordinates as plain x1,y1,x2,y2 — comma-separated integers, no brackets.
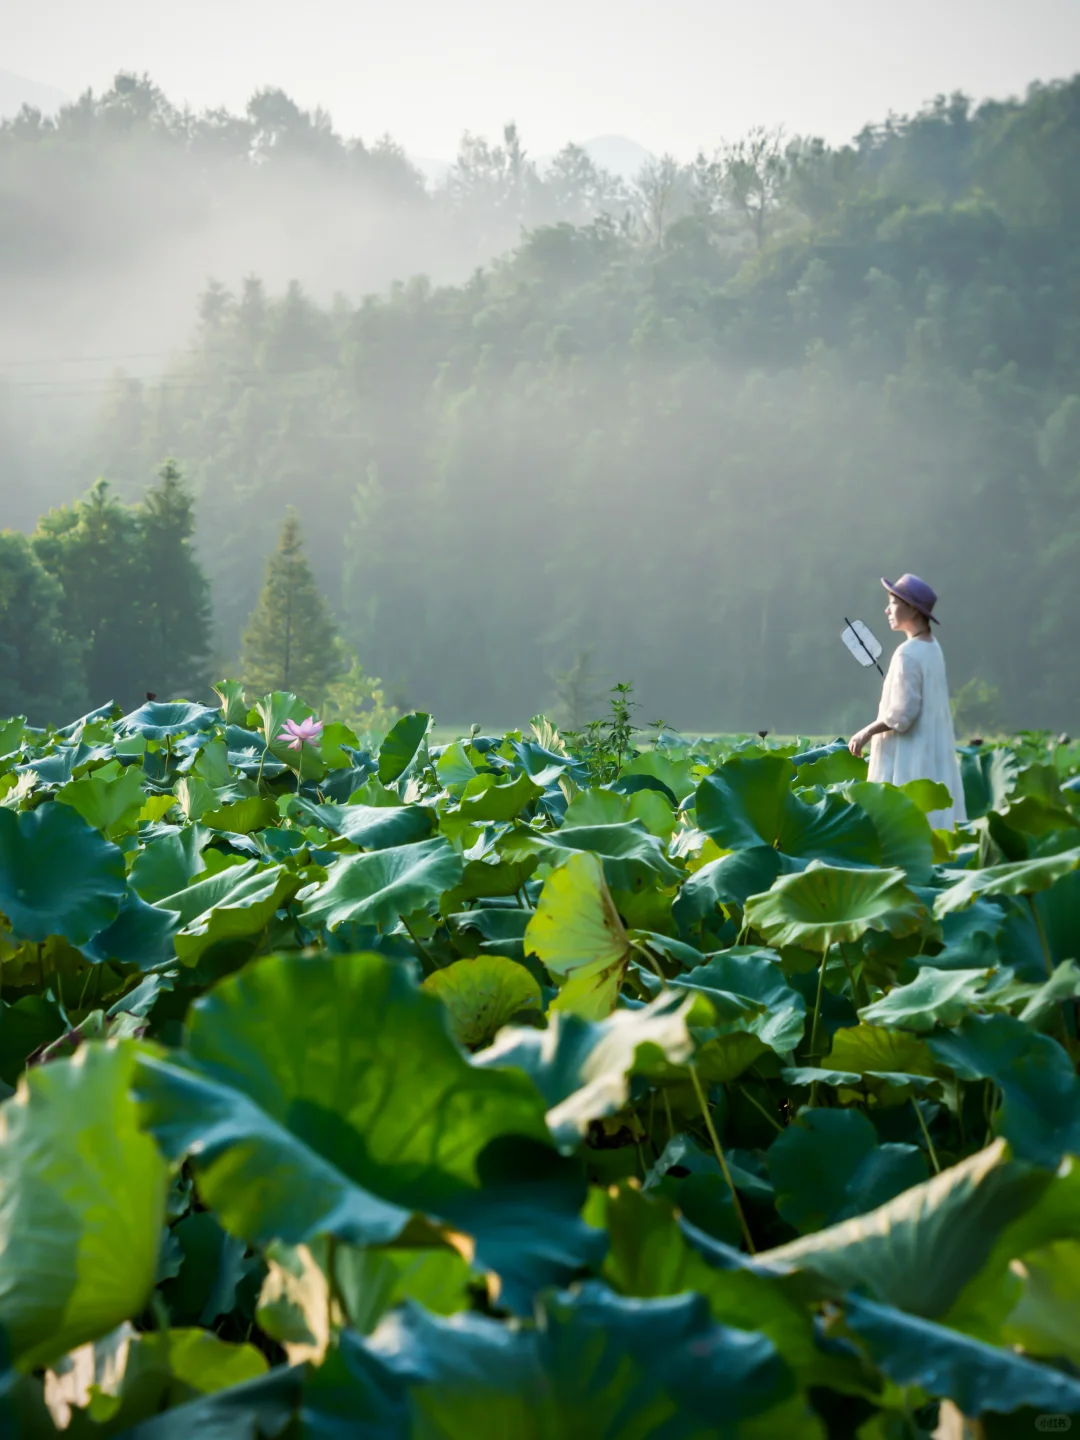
927,1015,1080,1168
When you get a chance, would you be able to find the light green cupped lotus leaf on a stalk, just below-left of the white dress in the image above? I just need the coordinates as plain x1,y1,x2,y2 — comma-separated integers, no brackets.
746,863,927,953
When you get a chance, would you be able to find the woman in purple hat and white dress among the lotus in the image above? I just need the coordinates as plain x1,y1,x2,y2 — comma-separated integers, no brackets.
848,575,968,829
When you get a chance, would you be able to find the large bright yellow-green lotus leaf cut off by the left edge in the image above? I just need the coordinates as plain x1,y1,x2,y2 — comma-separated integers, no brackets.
0,1044,166,1369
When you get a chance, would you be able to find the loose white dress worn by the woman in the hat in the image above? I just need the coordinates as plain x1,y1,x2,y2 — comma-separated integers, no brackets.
870,639,968,829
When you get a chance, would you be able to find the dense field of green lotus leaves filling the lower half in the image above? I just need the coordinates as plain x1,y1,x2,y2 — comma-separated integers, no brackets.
0,683,1080,1440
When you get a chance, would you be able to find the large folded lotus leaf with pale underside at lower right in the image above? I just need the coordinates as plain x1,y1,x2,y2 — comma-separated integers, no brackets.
757,1140,1053,1319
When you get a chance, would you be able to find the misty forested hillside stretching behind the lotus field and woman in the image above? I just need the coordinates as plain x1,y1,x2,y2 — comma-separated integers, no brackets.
0,76,1080,733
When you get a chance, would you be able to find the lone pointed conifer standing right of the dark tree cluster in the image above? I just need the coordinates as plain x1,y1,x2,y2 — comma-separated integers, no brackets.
240,508,341,706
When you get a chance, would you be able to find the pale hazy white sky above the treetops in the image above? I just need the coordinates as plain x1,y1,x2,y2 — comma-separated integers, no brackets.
0,0,1080,157
